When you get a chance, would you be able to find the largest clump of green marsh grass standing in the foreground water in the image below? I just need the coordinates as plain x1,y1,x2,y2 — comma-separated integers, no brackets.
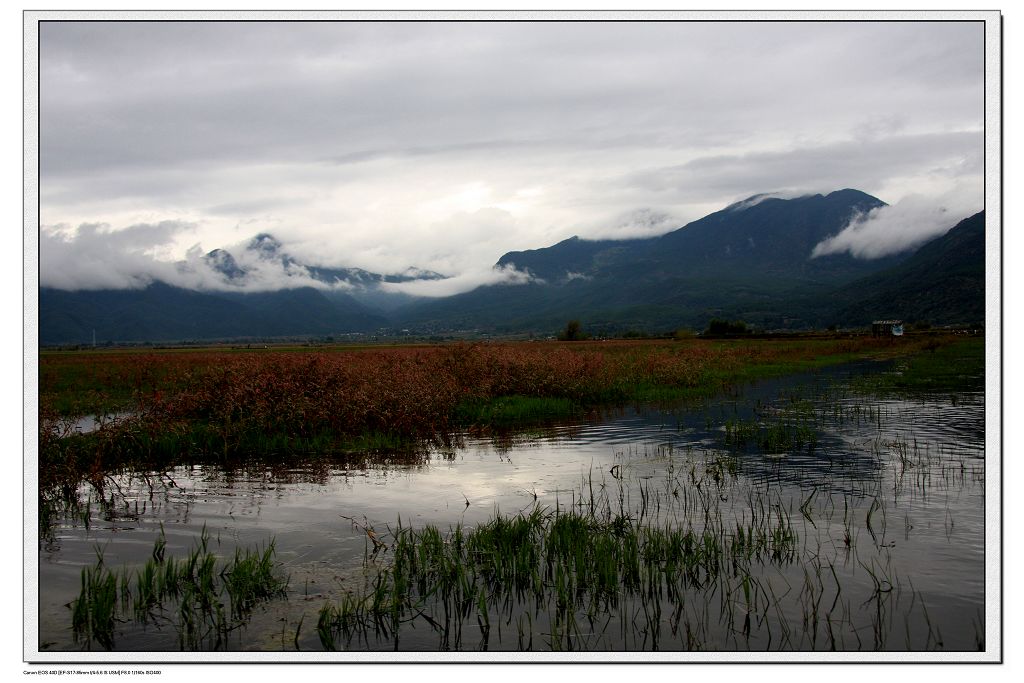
317,463,799,650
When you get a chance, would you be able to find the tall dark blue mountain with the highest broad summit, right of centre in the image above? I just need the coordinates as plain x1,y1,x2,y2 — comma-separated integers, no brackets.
396,189,937,332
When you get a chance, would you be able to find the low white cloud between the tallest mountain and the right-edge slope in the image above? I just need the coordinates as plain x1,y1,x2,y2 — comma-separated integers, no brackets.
811,186,983,259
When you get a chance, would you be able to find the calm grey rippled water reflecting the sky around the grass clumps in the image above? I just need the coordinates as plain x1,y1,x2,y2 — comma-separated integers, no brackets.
39,365,985,651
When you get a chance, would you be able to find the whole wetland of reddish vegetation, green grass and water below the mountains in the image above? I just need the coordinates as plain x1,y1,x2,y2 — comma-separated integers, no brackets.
38,336,986,653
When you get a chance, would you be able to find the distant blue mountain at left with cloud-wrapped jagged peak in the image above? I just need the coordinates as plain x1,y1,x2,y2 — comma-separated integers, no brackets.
39,233,441,344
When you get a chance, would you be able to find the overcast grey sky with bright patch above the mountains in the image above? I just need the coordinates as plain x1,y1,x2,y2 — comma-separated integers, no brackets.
39,22,984,294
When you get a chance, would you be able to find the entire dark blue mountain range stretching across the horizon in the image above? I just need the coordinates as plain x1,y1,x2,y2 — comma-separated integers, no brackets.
39,189,985,344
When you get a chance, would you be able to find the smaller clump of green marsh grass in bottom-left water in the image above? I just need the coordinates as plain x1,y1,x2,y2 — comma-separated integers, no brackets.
69,526,287,650
